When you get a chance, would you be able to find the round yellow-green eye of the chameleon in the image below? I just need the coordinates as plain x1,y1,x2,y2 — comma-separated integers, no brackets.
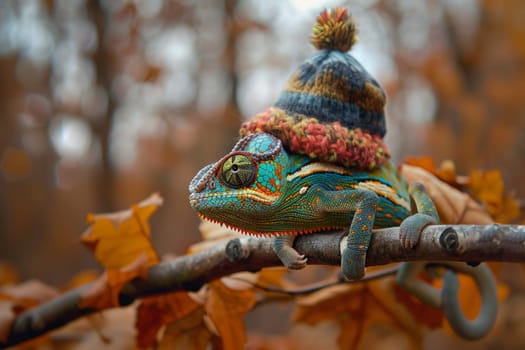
220,154,257,188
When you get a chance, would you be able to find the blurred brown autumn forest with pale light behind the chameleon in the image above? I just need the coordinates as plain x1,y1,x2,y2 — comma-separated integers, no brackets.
0,0,525,292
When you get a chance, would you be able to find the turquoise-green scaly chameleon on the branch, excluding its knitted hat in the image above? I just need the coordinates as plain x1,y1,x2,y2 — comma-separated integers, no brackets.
189,133,497,339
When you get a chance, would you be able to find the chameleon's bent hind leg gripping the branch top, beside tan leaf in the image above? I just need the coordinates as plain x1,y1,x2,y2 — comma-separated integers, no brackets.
399,182,439,248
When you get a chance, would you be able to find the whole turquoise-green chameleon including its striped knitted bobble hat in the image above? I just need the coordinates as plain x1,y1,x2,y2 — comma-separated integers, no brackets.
189,8,497,339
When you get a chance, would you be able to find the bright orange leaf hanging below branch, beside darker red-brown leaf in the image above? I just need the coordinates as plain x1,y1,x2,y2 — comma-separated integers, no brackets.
204,281,256,350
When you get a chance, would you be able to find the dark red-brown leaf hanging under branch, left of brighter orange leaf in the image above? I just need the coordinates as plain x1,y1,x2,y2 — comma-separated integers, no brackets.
135,292,202,348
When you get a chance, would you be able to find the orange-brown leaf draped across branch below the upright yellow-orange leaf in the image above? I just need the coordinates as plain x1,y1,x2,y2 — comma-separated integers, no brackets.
80,255,148,310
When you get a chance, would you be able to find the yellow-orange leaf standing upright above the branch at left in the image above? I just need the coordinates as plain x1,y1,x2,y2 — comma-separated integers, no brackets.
81,193,162,269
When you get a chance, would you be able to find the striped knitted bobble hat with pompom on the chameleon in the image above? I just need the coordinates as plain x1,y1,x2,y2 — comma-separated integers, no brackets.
240,7,390,170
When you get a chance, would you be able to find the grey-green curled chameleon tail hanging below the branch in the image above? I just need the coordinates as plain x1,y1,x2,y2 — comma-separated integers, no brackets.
397,261,498,340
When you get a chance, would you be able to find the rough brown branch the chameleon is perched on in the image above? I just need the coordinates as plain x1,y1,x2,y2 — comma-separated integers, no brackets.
0,224,525,348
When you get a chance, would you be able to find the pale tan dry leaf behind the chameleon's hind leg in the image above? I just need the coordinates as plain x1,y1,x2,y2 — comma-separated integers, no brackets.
401,164,494,225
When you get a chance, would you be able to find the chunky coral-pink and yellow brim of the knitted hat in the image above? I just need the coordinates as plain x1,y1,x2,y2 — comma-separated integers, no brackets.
240,107,390,170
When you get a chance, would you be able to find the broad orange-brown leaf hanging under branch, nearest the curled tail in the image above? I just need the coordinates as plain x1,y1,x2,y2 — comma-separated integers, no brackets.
293,278,422,349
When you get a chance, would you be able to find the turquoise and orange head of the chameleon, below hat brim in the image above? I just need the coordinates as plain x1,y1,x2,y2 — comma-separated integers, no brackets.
189,133,288,233
